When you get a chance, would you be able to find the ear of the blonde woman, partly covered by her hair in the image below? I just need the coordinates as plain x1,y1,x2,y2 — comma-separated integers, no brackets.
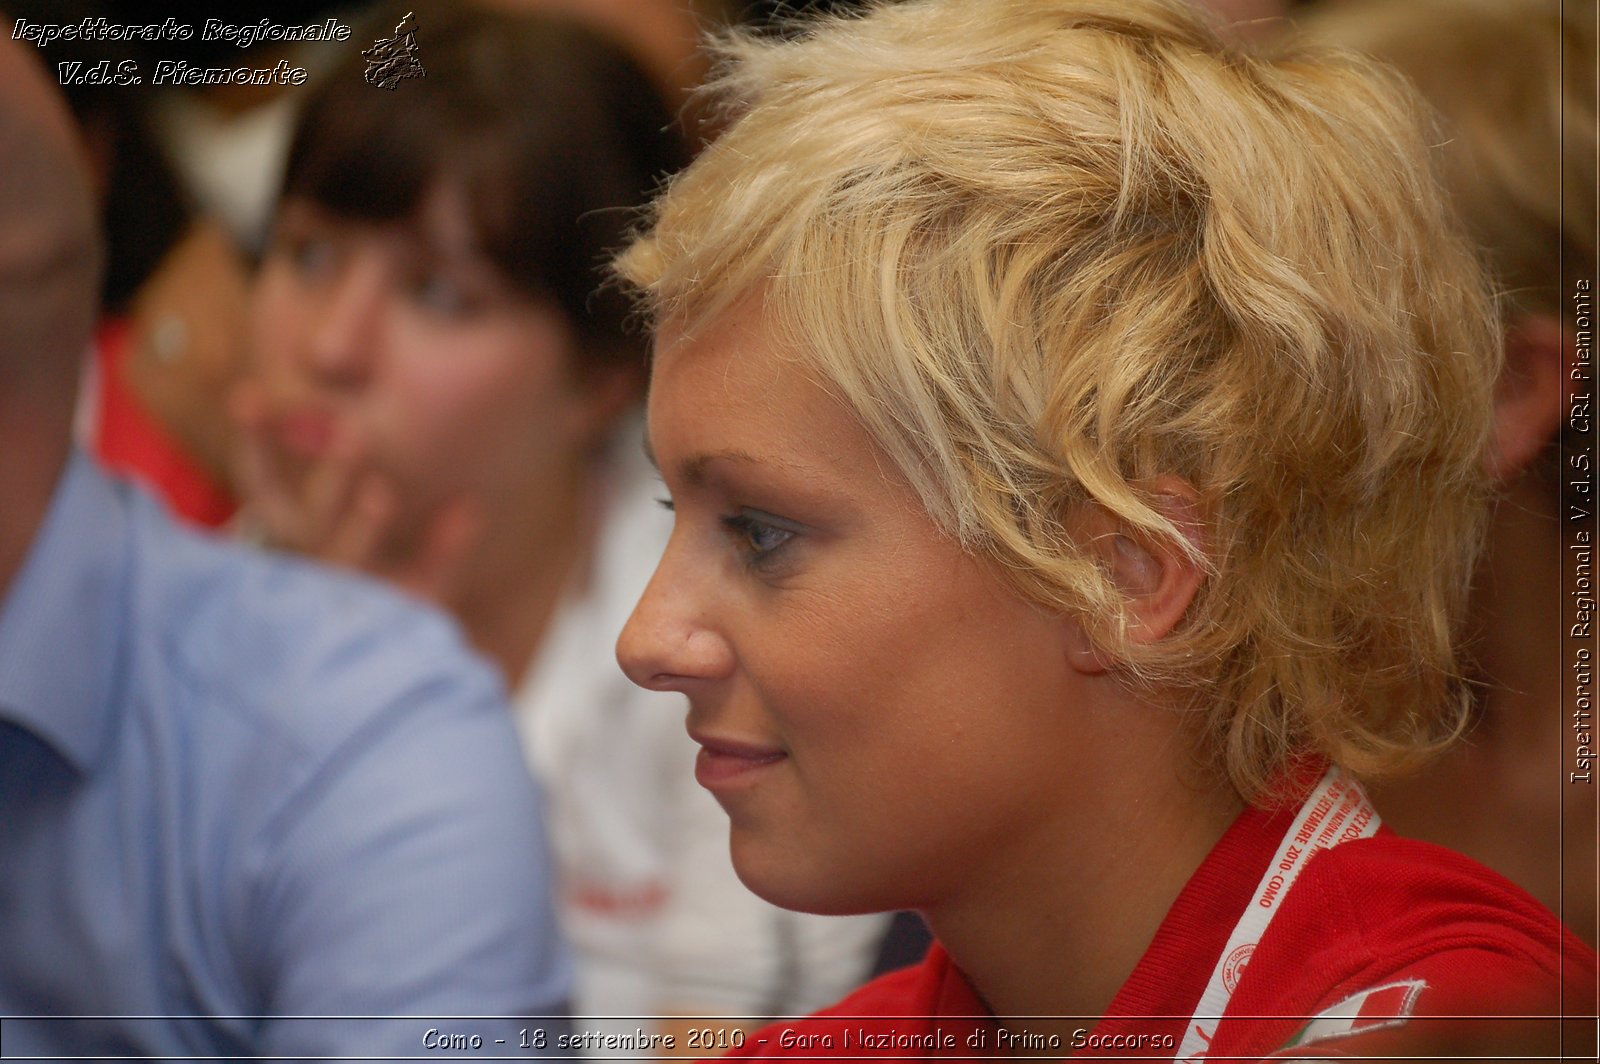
1067,475,1205,674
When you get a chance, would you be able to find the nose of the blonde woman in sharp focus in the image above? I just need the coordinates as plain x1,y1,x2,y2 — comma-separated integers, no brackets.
616,546,736,691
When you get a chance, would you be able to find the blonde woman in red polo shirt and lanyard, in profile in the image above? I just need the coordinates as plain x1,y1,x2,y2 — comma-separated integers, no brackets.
619,0,1594,1059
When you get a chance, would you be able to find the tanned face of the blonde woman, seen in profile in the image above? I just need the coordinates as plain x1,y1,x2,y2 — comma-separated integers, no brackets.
618,299,1086,912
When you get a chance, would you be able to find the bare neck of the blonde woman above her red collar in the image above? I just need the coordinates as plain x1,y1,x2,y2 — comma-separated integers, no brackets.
925,736,1243,1045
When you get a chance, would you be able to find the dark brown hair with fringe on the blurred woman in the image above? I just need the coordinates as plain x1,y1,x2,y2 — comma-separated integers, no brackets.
285,5,686,365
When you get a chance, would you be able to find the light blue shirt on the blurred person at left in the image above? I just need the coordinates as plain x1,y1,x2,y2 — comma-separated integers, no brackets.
0,456,568,1058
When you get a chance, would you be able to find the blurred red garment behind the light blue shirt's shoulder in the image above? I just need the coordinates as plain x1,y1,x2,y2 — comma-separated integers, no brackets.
88,318,237,528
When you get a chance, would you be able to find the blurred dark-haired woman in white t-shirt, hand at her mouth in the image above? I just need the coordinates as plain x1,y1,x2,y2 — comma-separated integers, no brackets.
235,6,878,1053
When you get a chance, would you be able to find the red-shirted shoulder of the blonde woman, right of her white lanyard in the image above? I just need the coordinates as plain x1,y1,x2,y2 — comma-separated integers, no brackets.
1211,830,1595,1059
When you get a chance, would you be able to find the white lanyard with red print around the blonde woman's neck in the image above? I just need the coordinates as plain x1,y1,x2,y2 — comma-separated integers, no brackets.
1173,766,1379,1064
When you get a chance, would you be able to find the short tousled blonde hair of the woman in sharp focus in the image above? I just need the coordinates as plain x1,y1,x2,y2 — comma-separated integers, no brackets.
618,0,1499,800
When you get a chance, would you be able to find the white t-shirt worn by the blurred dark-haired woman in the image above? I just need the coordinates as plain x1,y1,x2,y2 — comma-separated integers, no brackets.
514,430,888,1056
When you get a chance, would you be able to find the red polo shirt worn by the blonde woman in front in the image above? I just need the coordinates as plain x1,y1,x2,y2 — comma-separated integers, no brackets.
731,796,1597,1059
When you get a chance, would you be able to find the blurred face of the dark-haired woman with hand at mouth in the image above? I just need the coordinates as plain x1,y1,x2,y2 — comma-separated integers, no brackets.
251,187,598,520
